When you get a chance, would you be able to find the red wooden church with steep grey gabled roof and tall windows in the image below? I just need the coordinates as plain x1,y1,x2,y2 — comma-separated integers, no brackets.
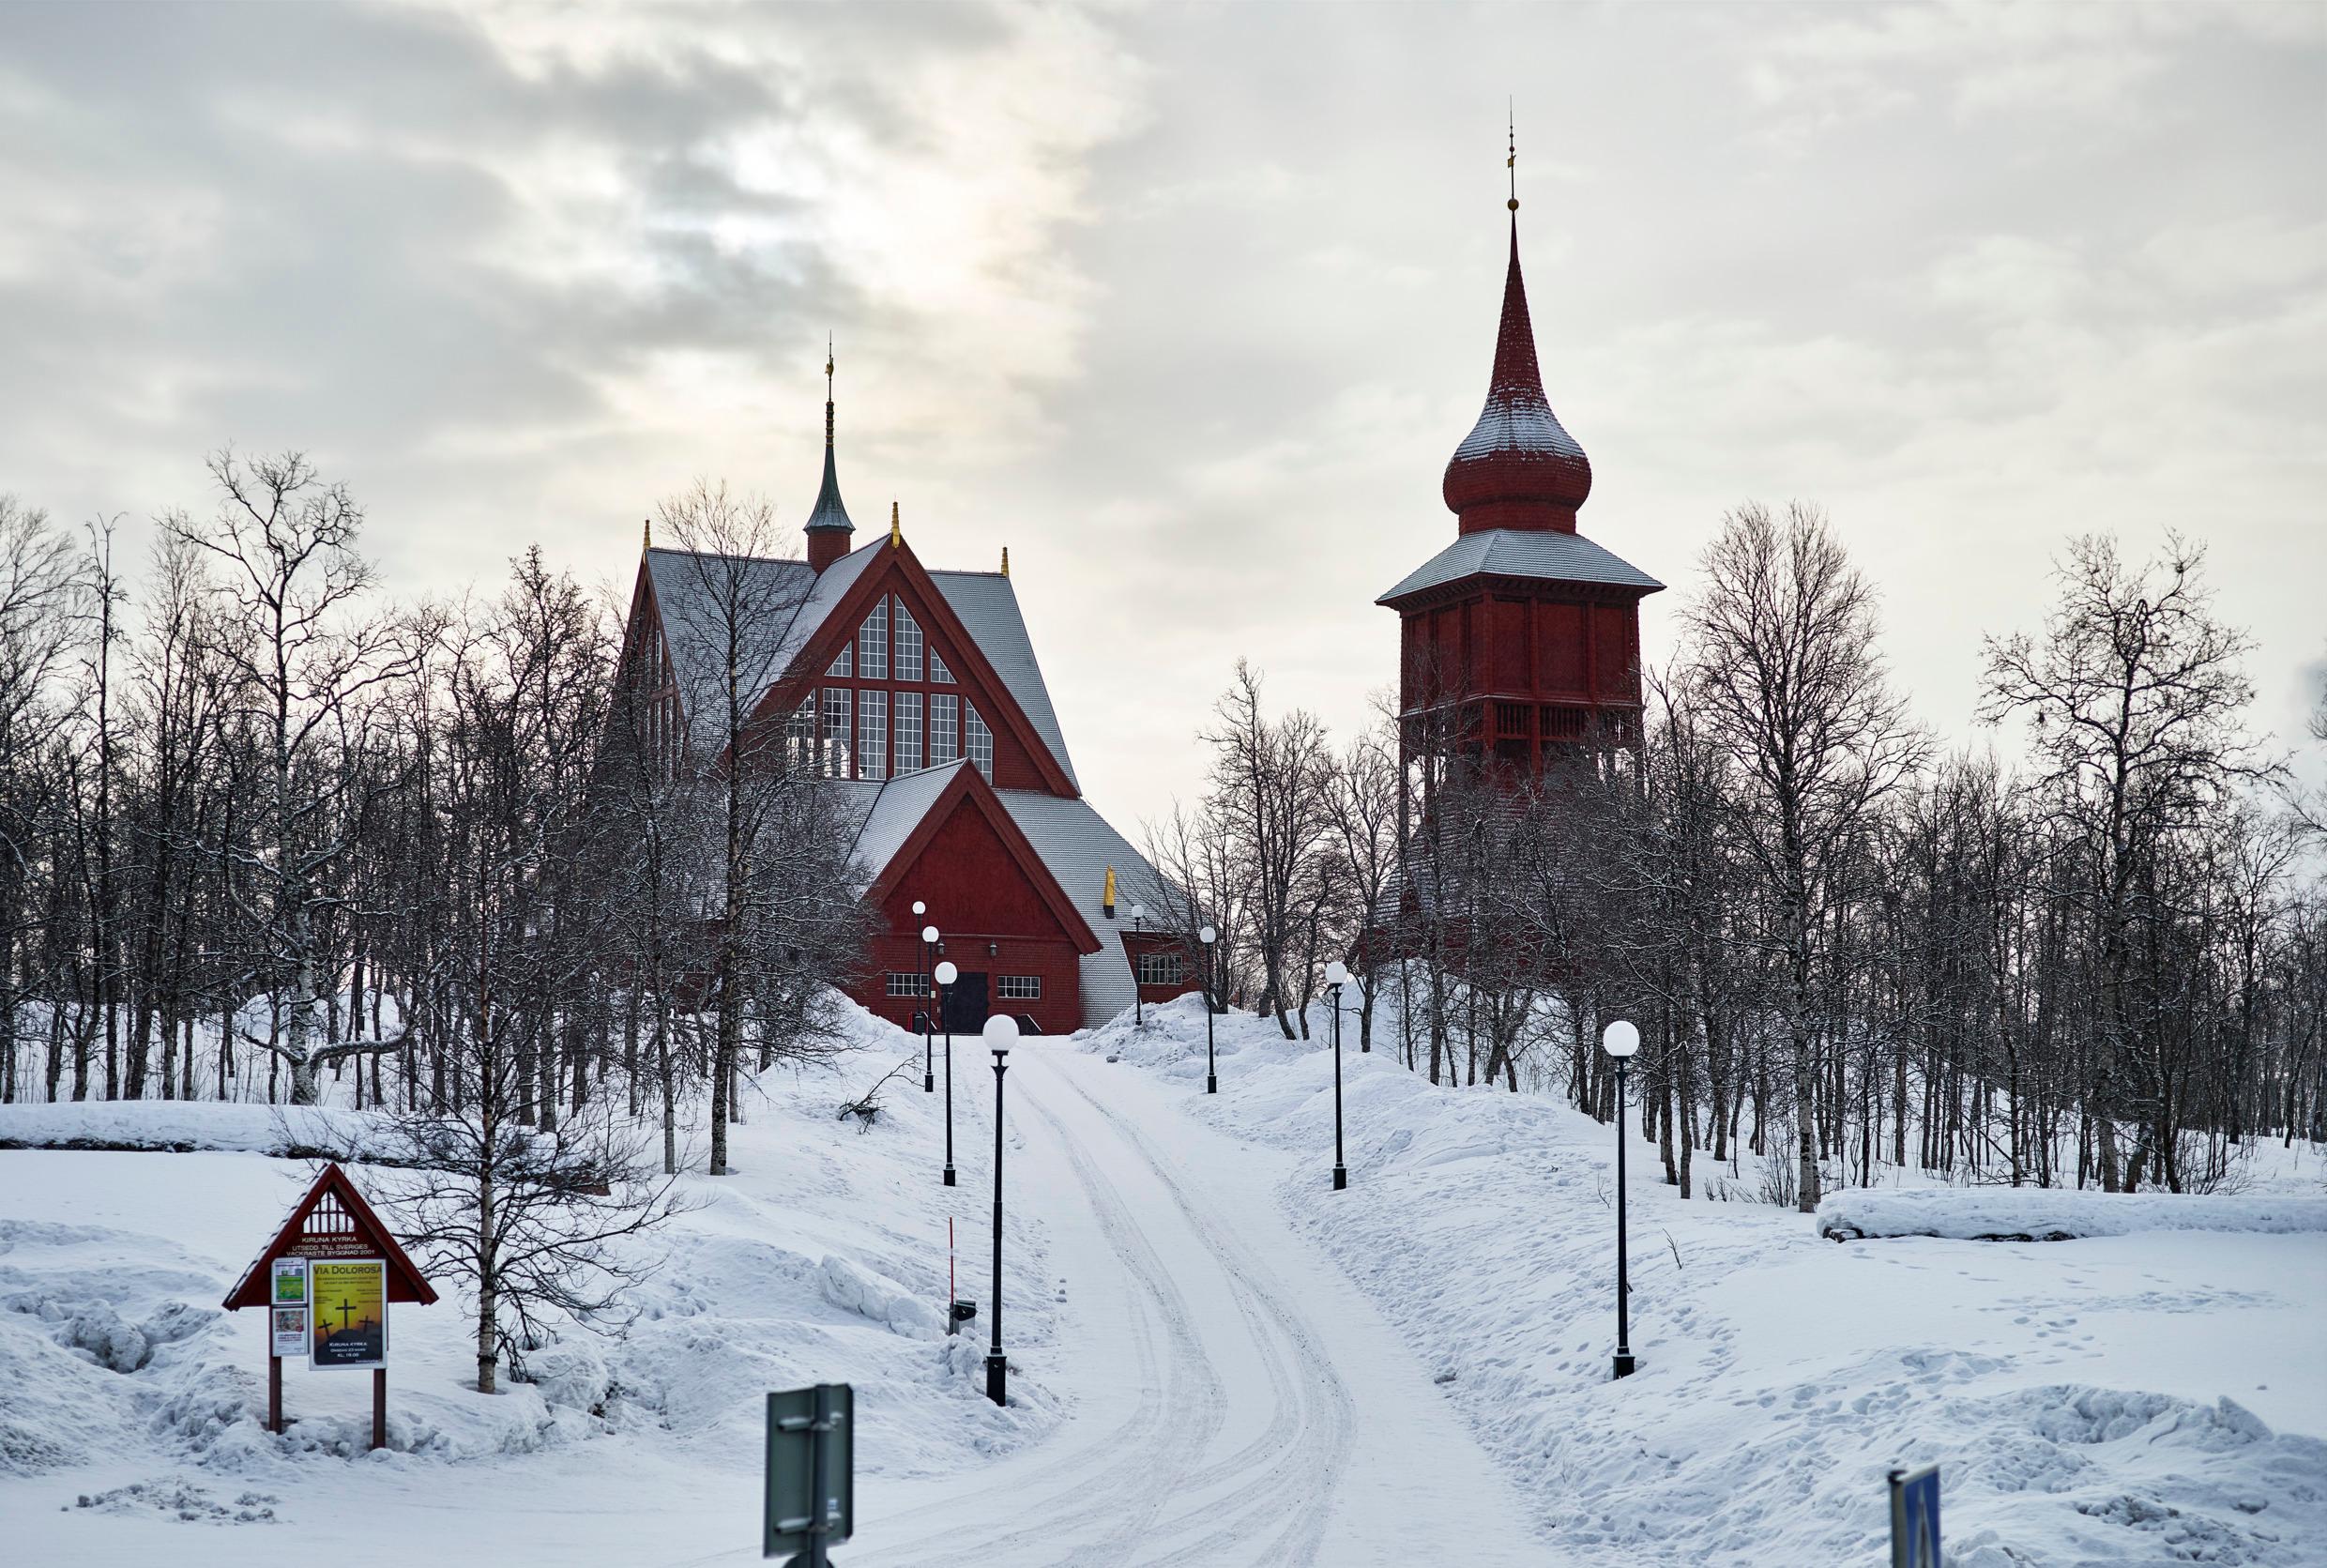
621,365,1194,1033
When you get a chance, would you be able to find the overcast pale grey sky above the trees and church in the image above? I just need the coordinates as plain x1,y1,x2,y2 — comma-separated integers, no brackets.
0,5,2327,830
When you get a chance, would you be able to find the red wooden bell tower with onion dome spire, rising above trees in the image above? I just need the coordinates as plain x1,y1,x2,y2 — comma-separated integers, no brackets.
1376,137,1664,775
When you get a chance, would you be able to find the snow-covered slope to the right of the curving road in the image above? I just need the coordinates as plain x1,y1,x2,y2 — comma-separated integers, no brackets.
1082,998,2327,1568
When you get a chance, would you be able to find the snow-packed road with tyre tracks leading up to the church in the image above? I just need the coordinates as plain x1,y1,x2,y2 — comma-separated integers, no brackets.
835,1043,1552,1568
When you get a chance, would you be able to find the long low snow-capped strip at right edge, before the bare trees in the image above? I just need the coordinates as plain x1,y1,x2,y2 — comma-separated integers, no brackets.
1817,1186,2327,1242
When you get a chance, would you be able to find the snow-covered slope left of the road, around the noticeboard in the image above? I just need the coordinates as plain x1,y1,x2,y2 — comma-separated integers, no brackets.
0,996,1061,1563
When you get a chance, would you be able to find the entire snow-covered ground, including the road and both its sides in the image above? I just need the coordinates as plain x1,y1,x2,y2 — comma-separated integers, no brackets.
0,1000,2327,1568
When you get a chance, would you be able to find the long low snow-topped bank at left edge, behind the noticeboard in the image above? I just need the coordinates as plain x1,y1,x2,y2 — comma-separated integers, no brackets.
0,1101,384,1159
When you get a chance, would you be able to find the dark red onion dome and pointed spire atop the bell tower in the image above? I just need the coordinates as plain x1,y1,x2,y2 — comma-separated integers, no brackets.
1443,125,1591,533
